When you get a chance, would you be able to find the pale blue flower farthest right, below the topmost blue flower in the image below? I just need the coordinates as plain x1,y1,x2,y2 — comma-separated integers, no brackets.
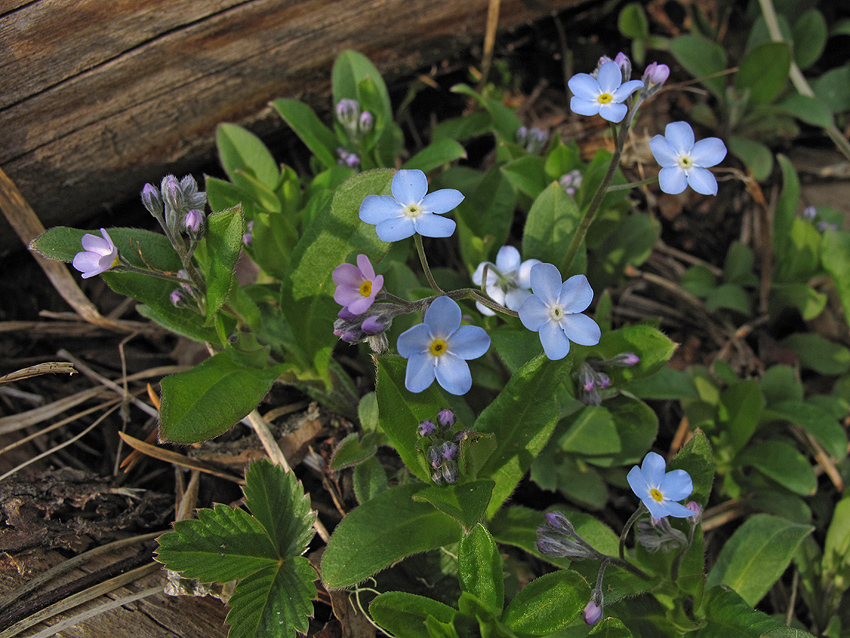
649,122,726,195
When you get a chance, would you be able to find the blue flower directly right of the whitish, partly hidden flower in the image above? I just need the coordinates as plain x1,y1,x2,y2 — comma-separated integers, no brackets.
519,264,604,360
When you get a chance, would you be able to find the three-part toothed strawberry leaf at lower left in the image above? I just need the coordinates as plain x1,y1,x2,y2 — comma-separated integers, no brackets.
156,461,316,638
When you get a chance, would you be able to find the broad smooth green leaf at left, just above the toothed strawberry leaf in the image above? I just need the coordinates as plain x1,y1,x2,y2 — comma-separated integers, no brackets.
161,352,282,443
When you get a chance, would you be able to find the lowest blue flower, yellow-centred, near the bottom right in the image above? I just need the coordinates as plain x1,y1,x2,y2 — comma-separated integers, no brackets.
626,452,696,518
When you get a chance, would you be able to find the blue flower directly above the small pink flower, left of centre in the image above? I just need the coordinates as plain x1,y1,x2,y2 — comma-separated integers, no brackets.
360,169,463,242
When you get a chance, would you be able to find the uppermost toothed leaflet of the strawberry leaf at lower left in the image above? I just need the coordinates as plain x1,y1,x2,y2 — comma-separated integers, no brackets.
245,461,316,560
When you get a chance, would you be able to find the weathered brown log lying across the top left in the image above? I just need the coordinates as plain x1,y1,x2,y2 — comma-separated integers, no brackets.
0,0,580,255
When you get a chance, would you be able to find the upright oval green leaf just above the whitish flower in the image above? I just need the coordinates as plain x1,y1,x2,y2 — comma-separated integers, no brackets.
522,181,581,269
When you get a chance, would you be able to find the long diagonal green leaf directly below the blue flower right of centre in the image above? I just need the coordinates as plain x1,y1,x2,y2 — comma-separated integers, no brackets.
472,355,570,518
